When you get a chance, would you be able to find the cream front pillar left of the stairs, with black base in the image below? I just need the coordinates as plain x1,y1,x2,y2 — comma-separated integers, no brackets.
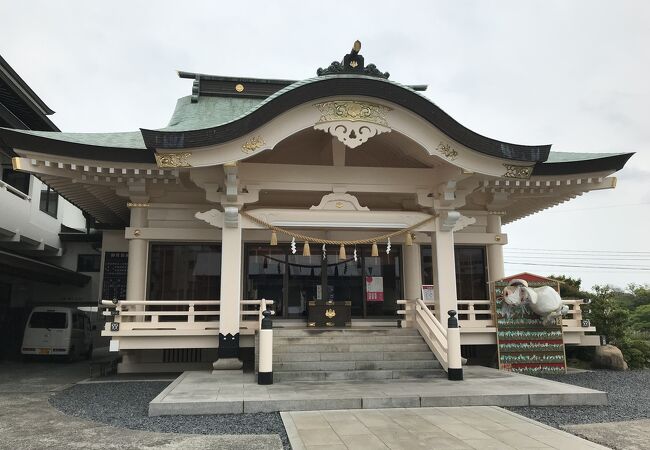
213,206,242,370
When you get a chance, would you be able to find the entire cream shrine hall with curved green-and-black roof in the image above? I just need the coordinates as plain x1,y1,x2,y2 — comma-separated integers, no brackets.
0,46,631,372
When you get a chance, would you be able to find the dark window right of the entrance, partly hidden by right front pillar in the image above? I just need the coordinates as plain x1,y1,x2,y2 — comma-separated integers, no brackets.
420,245,490,300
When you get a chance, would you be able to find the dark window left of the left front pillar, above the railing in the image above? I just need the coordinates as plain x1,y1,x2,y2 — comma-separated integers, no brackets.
148,243,221,300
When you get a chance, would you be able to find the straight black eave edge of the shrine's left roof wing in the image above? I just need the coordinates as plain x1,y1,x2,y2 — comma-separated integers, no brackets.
0,128,156,164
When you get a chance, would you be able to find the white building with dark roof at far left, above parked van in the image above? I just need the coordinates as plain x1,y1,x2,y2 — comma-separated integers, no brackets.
0,57,101,356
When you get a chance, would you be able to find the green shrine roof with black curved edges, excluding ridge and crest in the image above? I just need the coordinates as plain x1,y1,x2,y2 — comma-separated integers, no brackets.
0,74,633,176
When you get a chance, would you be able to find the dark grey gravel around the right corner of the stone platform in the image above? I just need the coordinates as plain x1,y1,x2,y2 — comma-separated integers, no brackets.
507,370,650,428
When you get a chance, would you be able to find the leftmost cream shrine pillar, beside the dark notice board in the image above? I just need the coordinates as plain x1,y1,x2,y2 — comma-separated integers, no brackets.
125,203,149,304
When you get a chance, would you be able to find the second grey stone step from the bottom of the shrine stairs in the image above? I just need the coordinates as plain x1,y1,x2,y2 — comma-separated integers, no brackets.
273,359,440,372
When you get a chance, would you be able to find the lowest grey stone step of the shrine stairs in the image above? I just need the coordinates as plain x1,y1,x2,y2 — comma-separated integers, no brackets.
273,369,447,382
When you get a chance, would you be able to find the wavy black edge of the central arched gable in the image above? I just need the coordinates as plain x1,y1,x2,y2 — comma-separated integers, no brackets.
140,76,551,162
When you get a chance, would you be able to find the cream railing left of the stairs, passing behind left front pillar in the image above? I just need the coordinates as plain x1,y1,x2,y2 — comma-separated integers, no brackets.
102,299,273,334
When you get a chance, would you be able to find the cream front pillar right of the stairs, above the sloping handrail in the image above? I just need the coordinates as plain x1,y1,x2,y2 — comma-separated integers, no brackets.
431,211,460,327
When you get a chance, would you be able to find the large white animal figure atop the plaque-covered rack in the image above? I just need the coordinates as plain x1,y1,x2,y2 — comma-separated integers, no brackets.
503,278,569,325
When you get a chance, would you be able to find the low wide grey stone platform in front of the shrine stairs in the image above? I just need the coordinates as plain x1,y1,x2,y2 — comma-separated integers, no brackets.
149,366,607,416
